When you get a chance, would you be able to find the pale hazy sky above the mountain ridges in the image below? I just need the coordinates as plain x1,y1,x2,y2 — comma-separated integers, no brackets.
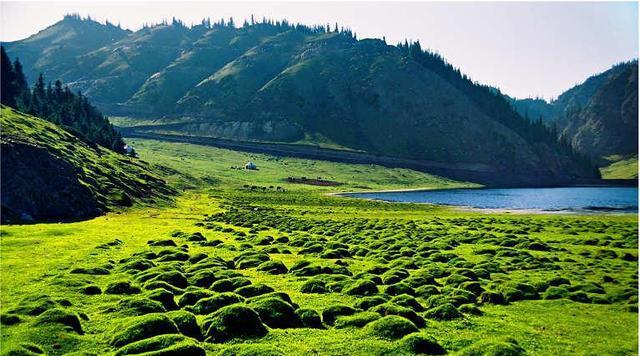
0,0,638,98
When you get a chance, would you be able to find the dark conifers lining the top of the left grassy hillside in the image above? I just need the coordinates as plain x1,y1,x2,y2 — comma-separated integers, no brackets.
0,47,124,152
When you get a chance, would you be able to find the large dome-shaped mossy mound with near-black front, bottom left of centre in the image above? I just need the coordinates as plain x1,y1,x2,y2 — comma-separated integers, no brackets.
203,304,268,342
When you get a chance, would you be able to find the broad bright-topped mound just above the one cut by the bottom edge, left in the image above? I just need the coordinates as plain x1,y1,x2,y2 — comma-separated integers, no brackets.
110,314,179,347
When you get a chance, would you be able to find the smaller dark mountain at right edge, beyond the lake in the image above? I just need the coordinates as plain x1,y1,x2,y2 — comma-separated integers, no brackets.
512,60,638,165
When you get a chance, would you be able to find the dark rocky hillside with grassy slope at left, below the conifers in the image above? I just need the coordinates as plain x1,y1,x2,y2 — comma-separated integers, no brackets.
0,105,173,224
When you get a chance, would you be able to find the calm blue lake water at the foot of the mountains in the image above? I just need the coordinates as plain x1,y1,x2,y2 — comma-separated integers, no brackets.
345,187,638,213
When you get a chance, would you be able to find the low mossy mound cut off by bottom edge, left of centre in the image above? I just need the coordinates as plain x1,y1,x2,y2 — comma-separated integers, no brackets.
115,334,206,356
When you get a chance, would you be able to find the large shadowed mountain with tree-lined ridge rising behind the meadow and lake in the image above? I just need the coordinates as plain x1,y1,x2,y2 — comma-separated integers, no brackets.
4,18,597,184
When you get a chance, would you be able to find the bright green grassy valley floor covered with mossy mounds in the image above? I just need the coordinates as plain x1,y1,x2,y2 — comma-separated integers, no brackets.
0,139,638,355
